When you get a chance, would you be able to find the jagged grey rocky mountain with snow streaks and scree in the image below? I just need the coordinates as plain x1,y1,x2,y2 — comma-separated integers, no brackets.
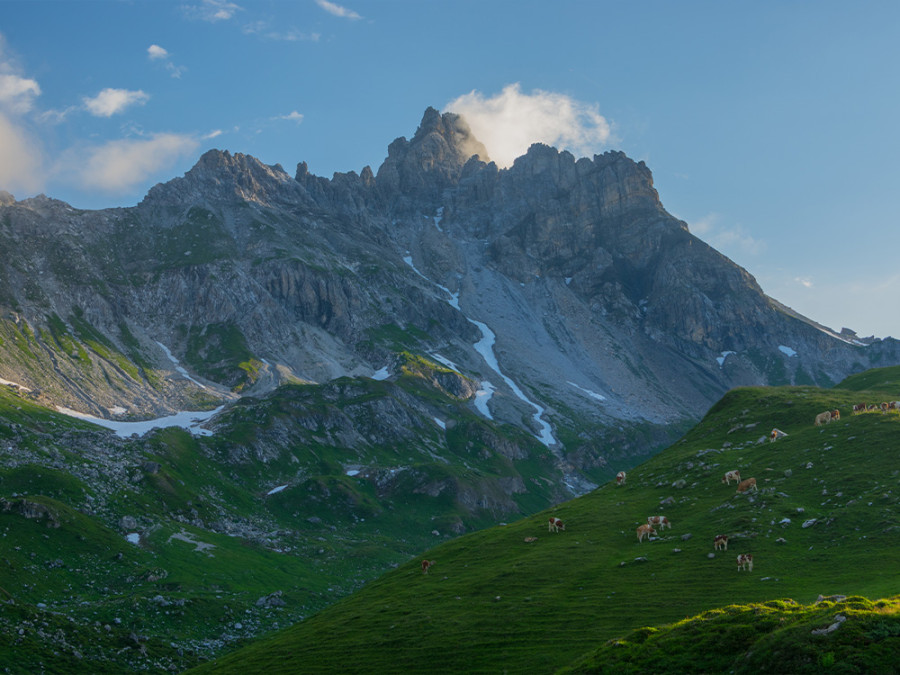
0,108,900,469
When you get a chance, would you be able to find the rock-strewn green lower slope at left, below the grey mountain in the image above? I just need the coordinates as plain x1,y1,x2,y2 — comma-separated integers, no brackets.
0,375,576,673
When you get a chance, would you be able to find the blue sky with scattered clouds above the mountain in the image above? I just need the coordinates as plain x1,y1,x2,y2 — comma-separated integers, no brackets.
0,0,900,337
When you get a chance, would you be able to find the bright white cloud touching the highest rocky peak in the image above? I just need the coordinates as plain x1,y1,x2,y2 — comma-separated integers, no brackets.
446,83,611,167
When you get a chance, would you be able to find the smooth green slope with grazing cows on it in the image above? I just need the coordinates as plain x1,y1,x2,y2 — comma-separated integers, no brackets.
190,380,900,673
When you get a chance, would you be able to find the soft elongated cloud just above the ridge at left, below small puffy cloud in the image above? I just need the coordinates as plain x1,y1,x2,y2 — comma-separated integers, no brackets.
57,134,200,193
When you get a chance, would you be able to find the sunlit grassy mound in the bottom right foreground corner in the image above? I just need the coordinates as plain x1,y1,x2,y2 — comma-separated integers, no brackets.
560,596,900,675
